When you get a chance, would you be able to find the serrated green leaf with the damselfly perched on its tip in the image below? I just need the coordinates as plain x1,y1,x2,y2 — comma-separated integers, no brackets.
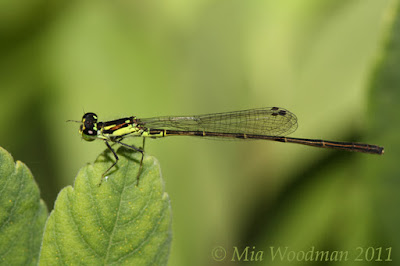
39,147,172,265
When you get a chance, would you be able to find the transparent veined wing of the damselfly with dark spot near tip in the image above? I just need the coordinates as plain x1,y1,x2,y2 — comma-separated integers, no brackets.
139,107,297,136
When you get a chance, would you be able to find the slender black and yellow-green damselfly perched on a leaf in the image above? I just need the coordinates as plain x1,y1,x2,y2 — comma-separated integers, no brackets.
69,107,384,185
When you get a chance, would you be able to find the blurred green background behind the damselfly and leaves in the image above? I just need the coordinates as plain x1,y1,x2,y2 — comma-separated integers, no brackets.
0,0,400,266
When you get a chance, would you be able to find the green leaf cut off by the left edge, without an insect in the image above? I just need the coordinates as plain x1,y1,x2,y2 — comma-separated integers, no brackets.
0,147,48,265
